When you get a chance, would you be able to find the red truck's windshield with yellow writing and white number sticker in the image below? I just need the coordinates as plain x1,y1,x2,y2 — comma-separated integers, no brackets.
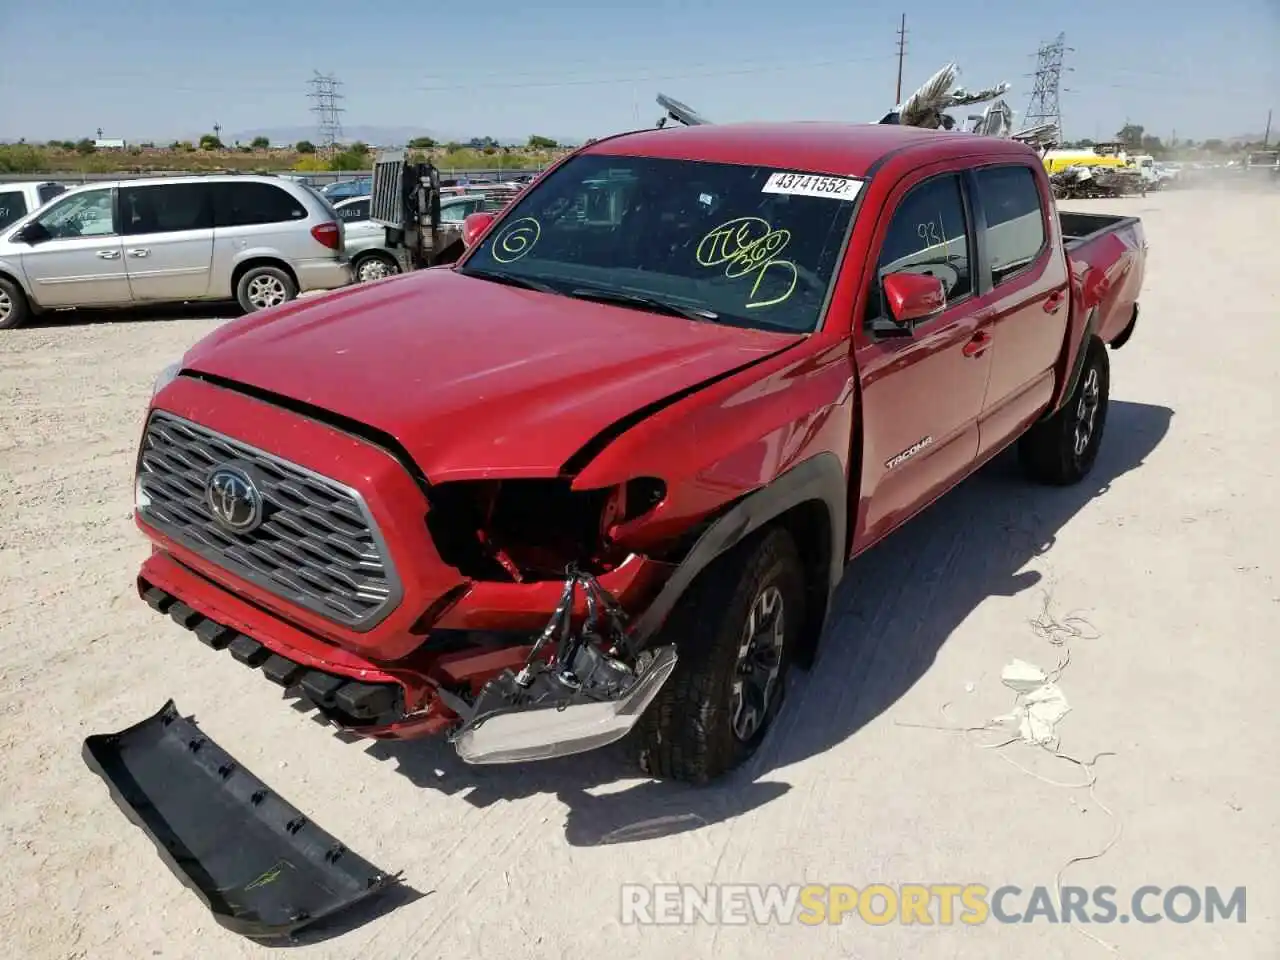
460,154,863,333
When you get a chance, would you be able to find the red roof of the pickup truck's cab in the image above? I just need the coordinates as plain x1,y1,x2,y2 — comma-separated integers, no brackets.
582,120,1036,177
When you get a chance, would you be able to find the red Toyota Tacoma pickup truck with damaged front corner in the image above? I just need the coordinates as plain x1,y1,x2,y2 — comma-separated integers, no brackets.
136,123,1146,782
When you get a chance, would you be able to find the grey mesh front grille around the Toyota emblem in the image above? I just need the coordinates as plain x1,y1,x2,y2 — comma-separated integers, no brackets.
138,411,401,630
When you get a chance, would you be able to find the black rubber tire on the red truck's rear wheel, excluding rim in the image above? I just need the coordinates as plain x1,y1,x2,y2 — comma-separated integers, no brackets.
1018,338,1111,486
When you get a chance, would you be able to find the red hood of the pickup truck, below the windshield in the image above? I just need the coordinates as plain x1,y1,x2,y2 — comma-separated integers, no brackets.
183,268,803,483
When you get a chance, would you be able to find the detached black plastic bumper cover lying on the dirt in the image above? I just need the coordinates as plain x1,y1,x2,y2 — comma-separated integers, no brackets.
83,700,396,940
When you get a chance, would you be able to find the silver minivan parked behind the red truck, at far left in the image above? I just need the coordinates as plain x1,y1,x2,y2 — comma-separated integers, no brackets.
0,174,352,329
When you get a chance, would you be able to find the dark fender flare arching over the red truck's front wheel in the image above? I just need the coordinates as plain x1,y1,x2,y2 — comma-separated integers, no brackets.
632,452,849,645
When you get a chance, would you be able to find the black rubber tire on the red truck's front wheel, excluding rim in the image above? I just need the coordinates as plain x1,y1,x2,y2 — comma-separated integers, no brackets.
632,527,805,783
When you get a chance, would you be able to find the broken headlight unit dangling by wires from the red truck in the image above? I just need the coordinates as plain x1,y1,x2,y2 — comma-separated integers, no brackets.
442,566,676,764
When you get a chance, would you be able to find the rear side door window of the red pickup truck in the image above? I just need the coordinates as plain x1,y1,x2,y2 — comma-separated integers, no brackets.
974,166,1048,285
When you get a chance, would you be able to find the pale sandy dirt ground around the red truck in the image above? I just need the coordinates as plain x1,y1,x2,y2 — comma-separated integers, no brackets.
0,191,1280,960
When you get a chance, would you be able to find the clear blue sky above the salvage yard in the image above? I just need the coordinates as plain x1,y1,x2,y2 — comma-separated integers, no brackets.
0,0,1280,142
